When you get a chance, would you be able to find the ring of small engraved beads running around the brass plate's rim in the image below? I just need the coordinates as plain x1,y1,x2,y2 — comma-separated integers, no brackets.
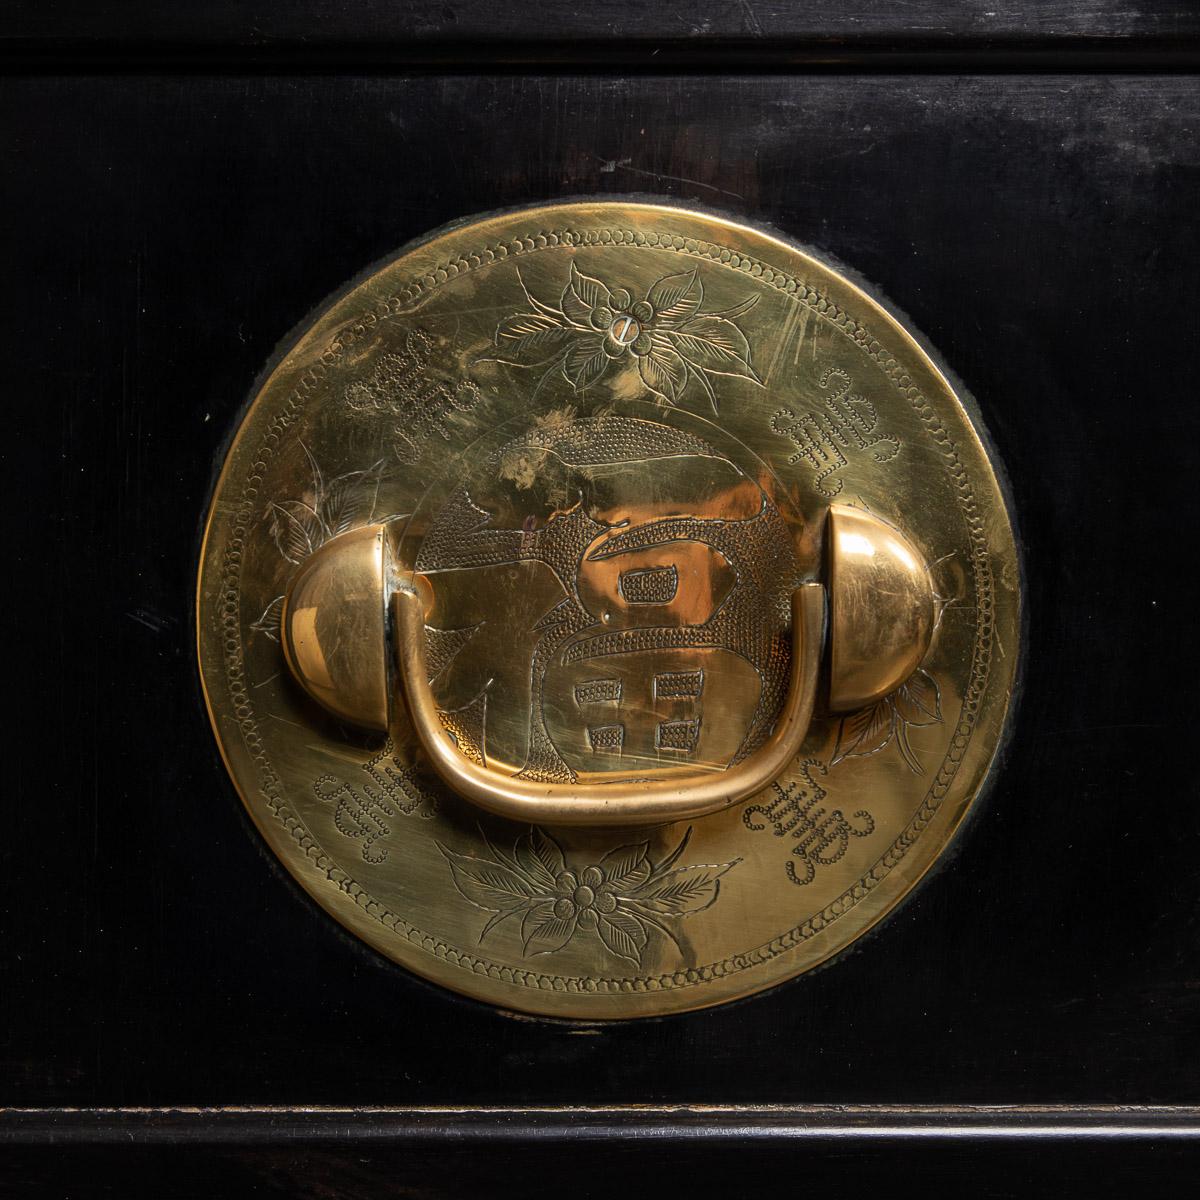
211,228,995,995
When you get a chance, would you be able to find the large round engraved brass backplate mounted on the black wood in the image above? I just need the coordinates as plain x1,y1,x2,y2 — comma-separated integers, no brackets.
198,200,1019,1019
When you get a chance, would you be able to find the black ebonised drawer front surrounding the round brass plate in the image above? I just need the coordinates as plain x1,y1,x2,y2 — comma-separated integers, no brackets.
0,28,1200,1195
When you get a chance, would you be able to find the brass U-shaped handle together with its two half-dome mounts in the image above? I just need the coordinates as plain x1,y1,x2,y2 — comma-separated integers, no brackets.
281,504,934,826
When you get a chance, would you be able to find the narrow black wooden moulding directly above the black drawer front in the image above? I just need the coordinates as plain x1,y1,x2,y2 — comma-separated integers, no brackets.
7,38,1200,74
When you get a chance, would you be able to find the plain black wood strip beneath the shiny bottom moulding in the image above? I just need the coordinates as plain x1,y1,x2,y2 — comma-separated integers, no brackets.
0,1114,1200,1200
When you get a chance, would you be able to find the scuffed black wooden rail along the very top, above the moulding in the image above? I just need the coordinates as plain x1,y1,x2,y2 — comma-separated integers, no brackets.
0,0,1200,47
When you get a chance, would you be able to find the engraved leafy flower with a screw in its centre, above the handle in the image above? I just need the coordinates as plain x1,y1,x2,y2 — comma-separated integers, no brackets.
496,263,762,412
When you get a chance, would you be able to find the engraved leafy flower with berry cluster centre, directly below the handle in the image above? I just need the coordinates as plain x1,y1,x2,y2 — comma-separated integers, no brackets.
438,828,740,965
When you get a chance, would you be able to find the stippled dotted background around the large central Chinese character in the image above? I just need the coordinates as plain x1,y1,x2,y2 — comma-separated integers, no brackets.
415,414,794,782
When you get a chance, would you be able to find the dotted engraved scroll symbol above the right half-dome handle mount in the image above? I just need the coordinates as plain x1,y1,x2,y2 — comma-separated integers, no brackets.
770,367,900,499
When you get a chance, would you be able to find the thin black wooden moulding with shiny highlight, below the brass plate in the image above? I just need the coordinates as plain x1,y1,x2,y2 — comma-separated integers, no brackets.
0,1105,1200,1146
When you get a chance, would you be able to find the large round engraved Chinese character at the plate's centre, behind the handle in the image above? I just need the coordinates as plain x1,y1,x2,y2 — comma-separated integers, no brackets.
415,414,797,782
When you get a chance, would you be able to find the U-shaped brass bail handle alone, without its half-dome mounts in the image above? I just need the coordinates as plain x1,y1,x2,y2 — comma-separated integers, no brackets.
391,583,824,826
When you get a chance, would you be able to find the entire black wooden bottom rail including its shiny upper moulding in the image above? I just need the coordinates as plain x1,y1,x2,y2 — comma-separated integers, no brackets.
0,1106,1200,1200
